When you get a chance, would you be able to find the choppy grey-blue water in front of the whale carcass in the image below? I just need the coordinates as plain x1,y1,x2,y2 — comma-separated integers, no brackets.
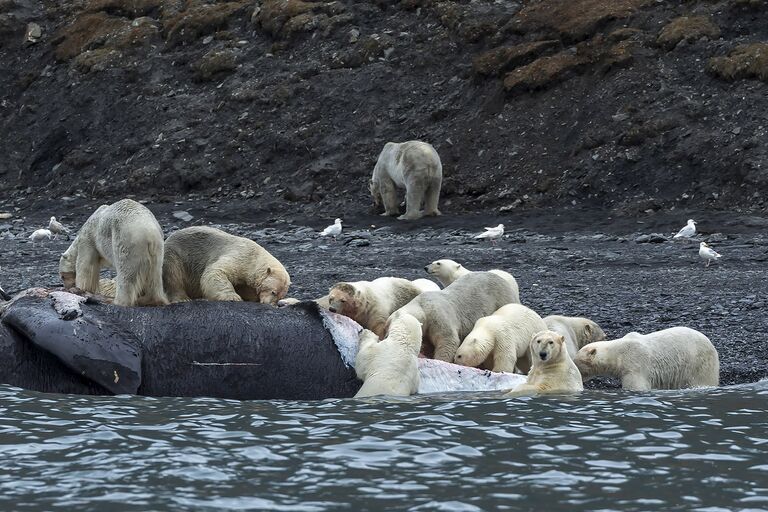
0,382,768,511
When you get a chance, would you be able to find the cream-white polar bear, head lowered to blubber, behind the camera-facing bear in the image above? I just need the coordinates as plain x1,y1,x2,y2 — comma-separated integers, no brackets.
453,304,547,373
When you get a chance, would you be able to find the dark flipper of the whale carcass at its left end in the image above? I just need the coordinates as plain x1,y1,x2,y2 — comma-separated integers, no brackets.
2,297,141,394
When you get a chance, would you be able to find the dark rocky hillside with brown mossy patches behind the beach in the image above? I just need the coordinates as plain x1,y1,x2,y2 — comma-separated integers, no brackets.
0,0,768,213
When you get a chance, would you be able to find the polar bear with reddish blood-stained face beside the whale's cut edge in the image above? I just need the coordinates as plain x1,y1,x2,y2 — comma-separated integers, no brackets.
328,277,434,338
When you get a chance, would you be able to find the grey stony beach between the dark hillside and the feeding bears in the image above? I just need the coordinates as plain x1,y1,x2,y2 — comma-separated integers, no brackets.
0,202,768,385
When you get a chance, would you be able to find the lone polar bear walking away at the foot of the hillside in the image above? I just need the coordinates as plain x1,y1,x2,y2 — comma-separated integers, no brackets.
369,140,443,220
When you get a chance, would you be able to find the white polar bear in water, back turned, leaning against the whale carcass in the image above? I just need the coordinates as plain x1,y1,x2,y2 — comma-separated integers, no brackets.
355,315,421,398
